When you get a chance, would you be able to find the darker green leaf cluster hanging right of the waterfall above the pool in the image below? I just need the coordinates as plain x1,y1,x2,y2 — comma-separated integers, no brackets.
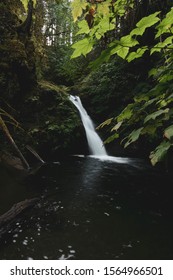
100,59,173,165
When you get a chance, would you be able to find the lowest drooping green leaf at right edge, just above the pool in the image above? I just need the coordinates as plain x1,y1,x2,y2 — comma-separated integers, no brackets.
150,141,171,165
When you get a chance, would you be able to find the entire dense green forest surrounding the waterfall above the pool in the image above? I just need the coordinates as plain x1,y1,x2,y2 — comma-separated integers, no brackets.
0,0,173,165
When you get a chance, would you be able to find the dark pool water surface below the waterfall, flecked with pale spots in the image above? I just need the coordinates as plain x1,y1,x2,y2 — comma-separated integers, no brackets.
0,157,173,259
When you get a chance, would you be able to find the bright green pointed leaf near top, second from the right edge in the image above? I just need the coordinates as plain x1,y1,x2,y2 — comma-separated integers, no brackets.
130,12,160,36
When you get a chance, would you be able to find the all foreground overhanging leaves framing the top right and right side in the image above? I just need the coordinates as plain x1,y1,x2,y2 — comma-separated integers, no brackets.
72,0,173,165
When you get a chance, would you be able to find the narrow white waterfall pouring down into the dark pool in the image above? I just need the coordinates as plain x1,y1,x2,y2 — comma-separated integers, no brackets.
70,95,107,156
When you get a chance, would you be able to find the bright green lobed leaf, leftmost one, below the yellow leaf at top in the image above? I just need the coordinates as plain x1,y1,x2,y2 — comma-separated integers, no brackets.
71,38,93,58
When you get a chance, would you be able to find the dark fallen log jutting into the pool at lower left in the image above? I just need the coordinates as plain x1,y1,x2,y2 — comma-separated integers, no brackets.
0,198,39,238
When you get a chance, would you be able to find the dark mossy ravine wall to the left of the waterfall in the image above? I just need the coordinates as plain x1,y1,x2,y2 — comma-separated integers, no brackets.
0,0,84,166
